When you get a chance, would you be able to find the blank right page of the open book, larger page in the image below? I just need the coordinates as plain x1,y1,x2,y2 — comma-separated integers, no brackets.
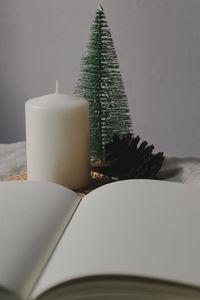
33,180,200,297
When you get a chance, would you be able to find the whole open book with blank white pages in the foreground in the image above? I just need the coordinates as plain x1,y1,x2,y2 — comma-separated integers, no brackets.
0,180,200,300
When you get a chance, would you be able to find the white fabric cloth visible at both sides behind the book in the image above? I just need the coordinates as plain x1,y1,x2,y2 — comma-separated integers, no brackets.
0,141,200,186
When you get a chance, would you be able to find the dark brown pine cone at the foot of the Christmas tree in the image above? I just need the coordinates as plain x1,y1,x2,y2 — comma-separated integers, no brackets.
92,134,164,180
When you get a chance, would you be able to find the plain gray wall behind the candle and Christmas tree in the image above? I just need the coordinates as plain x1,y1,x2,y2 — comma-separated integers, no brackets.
0,0,200,156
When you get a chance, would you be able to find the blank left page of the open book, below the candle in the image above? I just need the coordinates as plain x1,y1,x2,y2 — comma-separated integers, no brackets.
0,181,80,298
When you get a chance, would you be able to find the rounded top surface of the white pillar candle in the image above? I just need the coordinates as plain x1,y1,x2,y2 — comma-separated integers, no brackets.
26,93,89,109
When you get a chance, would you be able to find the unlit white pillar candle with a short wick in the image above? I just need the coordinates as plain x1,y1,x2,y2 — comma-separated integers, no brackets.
25,82,89,190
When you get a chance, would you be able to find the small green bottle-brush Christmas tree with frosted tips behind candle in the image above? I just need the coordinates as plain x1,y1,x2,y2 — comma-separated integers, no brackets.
74,5,132,161
